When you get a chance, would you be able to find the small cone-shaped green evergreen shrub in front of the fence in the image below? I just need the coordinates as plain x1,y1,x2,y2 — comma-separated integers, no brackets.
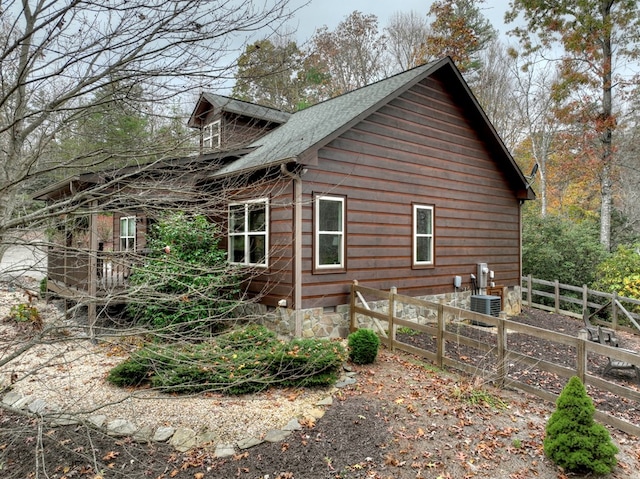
543,376,618,474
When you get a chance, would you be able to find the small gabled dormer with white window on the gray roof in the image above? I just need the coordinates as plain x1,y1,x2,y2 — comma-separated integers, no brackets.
188,93,291,153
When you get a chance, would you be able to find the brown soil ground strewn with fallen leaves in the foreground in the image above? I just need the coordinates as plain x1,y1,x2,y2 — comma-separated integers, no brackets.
0,310,640,479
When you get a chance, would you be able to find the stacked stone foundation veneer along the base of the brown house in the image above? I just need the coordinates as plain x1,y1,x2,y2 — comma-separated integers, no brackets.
248,286,522,339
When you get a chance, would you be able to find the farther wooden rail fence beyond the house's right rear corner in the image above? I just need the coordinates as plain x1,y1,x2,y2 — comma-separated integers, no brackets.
522,275,640,334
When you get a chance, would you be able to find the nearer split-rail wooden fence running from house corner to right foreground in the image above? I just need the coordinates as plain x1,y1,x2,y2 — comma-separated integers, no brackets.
350,282,640,437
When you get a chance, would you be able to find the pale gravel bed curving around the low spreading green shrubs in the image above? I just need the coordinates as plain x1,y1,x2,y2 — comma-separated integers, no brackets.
0,285,331,443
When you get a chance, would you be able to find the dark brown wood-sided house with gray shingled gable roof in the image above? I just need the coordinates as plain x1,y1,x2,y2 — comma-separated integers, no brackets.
35,57,535,336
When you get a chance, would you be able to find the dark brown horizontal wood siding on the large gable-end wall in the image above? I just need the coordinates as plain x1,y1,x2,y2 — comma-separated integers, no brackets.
302,77,520,308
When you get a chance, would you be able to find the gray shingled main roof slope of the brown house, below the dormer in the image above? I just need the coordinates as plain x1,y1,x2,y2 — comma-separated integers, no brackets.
215,60,446,176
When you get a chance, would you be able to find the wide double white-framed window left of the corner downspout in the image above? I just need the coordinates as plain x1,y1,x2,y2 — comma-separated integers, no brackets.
229,198,269,267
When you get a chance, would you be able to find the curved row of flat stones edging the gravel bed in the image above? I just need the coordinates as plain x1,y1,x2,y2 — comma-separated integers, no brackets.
2,372,356,458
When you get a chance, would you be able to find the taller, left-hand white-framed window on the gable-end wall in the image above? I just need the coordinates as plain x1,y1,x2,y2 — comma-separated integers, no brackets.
314,196,345,269
